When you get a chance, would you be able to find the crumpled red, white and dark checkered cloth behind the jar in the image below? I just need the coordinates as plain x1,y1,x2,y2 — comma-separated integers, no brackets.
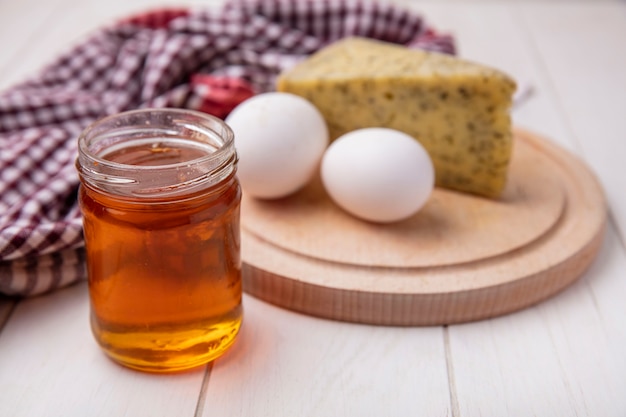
0,0,454,296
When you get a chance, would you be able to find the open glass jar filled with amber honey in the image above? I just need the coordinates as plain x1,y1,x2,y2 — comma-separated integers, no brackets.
76,109,242,372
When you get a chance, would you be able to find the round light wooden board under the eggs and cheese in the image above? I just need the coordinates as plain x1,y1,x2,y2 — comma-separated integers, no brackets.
241,129,606,326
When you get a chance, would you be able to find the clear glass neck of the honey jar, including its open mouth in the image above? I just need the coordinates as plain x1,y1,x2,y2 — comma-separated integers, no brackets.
76,109,237,199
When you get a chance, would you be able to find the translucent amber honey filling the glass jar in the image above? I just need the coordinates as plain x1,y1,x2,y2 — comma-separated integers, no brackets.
79,141,242,372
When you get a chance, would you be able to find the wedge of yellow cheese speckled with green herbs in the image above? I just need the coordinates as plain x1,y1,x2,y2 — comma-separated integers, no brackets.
277,38,515,197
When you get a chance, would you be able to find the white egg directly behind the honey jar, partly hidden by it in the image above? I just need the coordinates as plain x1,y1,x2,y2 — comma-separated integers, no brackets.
226,92,328,199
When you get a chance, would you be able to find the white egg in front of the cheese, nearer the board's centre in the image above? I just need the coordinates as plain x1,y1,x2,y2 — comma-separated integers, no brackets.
321,128,435,223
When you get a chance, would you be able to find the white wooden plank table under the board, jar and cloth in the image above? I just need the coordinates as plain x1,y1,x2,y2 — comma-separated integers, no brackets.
0,0,626,417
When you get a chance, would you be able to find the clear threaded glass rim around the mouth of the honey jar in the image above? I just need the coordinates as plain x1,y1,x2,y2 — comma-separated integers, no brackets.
76,108,237,196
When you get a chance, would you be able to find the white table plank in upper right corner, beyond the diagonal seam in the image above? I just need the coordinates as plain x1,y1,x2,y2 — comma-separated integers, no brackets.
521,2,626,250
